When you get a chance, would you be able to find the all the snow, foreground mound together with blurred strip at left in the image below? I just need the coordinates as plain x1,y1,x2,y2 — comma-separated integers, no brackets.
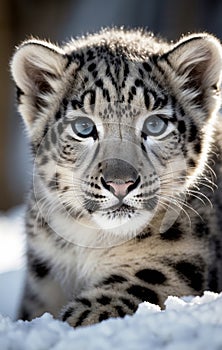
0,209,222,350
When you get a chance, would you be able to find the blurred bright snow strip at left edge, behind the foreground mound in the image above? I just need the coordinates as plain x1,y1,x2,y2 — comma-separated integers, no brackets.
0,207,25,322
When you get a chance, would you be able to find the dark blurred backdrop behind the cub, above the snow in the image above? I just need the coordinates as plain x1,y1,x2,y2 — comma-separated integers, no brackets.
0,0,222,211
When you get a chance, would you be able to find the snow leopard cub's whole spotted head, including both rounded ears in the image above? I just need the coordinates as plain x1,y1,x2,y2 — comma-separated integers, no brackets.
12,31,222,236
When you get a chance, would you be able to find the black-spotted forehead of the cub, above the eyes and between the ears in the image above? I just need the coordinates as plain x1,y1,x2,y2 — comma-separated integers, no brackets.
71,47,166,120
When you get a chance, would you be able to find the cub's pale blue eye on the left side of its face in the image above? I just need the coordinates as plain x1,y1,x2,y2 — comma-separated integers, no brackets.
71,117,97,138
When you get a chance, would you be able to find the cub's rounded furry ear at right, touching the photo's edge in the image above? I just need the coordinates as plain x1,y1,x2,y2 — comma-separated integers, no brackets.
163,34,222,108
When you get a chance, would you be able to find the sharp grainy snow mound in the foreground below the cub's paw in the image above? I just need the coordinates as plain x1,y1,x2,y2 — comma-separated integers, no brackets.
0,292,222,350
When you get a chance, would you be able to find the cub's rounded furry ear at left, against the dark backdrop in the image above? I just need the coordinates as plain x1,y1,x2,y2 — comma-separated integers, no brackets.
11,40,67,124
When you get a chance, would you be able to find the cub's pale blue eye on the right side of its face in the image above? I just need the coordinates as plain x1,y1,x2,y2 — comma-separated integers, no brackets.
143,115,168,136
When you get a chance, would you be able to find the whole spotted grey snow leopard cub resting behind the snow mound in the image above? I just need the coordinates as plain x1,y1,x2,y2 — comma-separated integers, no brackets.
11,28,222,327
